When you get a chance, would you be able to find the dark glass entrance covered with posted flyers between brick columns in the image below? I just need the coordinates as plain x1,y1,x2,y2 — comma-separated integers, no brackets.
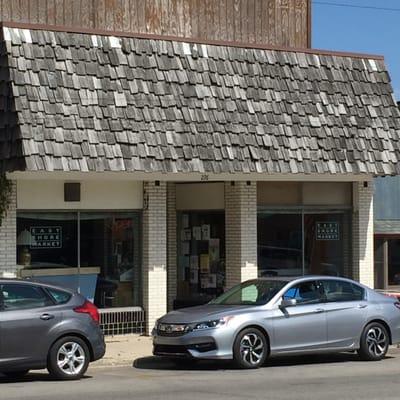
174,211,225,308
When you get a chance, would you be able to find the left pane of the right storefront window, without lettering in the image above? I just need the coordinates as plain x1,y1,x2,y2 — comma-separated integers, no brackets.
257,212,302,276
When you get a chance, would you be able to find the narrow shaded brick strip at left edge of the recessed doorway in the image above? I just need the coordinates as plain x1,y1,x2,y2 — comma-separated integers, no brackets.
167,182,177,310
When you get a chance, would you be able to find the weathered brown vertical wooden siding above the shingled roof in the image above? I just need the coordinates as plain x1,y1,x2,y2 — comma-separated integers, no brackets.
0,0,311,48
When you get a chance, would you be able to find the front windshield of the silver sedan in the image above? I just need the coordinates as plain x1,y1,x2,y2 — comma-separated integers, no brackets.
210,280,287,306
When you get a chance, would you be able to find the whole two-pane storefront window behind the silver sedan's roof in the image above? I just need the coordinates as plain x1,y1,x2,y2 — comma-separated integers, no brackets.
257,209,351,276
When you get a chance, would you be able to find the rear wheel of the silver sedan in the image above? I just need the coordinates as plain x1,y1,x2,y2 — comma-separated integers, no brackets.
358,322,390,361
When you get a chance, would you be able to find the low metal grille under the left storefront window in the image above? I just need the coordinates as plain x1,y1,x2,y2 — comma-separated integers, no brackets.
99,307,146,335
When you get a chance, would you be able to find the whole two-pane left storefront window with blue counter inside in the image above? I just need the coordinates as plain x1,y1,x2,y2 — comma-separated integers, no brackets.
17,212,141,307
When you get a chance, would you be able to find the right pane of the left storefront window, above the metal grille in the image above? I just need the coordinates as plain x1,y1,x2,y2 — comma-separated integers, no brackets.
80,212,141,307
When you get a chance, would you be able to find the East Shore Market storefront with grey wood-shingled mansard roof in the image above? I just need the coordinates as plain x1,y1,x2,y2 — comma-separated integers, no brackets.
0,1,400,331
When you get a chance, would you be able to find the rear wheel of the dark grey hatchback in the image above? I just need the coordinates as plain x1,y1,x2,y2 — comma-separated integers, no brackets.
47,336,90,380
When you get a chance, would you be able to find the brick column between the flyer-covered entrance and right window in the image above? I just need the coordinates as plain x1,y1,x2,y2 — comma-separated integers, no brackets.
225,182,257,288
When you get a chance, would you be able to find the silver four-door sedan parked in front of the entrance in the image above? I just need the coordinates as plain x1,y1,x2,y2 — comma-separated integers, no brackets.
153,276,400,368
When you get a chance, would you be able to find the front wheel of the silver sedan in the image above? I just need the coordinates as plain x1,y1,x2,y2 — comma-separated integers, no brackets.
233,328,269,369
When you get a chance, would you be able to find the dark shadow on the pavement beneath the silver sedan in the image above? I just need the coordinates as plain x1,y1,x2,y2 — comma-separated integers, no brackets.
132,353,393,371
